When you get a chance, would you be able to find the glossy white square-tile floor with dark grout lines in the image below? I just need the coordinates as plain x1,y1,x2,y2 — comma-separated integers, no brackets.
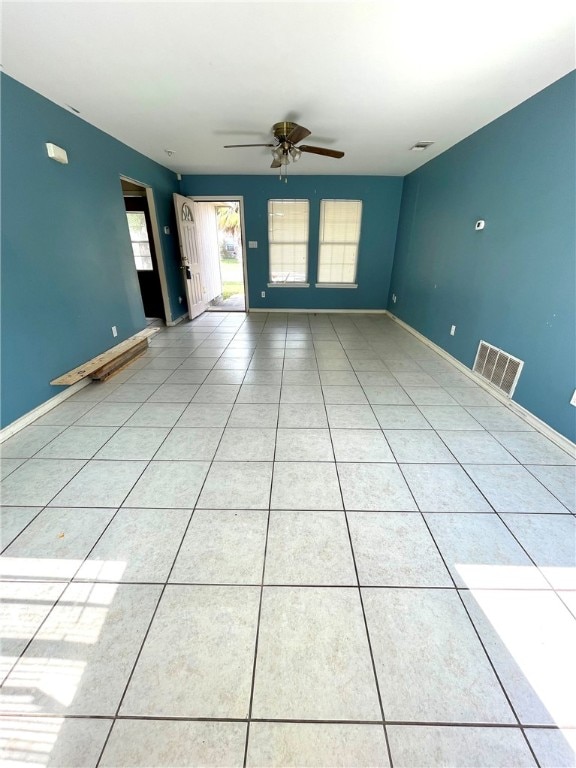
0,313,576,768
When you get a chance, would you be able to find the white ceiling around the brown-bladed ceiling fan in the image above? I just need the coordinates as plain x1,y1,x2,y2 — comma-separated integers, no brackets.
2,0,576,175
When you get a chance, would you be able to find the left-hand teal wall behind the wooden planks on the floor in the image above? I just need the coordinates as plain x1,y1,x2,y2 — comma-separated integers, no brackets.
0,75,183,426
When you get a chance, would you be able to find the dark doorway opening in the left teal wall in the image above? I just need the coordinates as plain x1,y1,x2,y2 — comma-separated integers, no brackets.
120,179,168,323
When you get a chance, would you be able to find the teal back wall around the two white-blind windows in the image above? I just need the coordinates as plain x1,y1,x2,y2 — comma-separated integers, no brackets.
182,176,402,310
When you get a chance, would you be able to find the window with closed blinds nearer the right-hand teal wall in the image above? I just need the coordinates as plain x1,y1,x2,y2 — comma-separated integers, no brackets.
318,200,362,285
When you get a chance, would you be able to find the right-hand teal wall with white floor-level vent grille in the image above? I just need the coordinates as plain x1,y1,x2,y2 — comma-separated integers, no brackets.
389,73,576,440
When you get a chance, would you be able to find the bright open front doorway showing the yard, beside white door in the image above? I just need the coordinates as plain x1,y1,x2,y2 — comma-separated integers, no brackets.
192,197,248,312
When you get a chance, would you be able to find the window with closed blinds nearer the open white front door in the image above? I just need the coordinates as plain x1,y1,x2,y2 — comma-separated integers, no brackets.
268,200,309,285
